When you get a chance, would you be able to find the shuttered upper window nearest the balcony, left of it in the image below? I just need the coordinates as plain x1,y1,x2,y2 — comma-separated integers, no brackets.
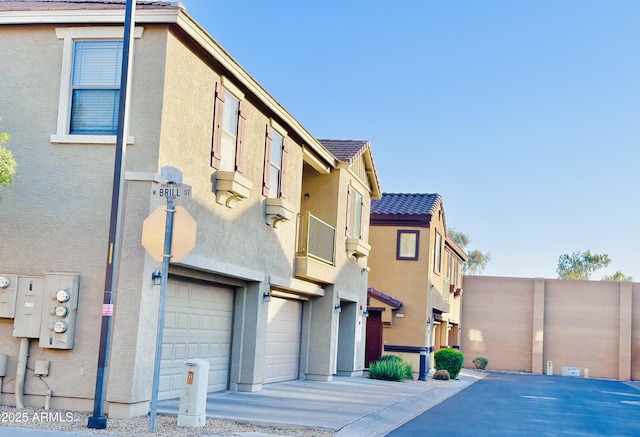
262,120,288,199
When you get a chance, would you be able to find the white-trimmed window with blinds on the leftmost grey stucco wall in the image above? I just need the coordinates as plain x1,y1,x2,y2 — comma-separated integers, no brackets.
50,27,143,144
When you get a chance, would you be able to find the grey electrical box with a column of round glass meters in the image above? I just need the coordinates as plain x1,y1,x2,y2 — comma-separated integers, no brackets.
39,273,80,349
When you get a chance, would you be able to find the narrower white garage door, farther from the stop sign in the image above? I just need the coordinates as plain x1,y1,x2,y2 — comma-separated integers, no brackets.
264,297,302,383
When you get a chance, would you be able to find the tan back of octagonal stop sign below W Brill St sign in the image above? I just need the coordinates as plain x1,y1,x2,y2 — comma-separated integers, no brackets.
142,206,197,262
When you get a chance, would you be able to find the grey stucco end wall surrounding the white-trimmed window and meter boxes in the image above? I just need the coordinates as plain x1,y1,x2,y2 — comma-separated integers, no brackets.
0,26,164,406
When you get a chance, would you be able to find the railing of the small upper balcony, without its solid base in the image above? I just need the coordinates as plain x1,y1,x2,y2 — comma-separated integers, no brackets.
298,211,336,265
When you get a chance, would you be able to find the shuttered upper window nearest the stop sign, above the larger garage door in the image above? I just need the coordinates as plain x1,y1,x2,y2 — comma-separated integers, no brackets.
211,77,246,173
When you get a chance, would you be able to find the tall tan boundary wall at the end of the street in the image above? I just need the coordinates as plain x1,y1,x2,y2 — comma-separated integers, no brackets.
462,276,640,380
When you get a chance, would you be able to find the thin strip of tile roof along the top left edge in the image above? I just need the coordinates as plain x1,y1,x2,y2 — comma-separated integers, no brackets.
0,0,179,11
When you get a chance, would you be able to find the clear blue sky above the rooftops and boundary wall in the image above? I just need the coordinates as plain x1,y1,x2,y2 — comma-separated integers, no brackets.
182,0,640,281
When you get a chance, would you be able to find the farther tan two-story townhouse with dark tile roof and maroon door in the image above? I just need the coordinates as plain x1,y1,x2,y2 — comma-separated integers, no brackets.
365,193,466,369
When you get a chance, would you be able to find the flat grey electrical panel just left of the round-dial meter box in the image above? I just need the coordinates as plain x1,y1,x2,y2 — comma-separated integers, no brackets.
13,276,44,338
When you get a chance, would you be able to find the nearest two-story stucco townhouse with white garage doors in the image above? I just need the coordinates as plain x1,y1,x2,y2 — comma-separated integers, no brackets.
0,0,380,417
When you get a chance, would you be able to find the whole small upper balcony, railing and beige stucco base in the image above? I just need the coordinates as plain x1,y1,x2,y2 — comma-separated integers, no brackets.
296,212,336,284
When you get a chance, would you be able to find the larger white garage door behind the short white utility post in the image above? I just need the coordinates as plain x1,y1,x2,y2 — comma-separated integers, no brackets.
158,279,234,399
